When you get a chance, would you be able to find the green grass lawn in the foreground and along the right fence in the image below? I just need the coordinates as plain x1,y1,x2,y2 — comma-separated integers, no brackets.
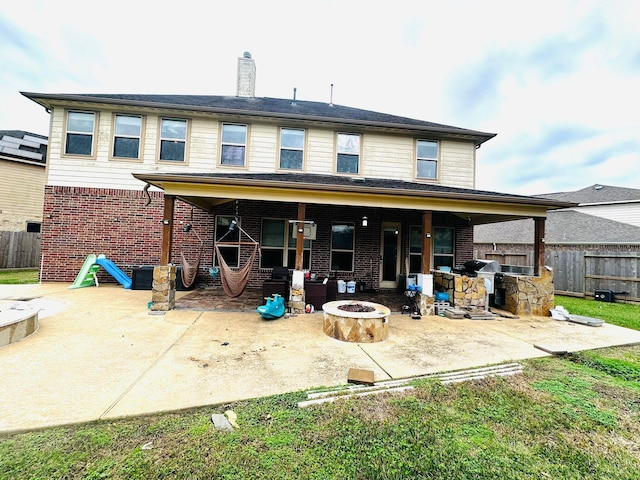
0,298,640,480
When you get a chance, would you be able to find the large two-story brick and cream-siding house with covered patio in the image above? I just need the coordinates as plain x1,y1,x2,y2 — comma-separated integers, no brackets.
23,55,569,300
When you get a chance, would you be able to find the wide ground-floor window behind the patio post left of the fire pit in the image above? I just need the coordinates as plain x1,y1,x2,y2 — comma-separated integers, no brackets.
260,218,311,269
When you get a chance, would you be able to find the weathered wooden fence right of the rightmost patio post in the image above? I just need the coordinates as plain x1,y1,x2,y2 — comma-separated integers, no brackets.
545,250,640,301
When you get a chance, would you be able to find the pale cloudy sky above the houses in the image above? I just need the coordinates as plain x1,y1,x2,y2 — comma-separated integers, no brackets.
0,0,640,195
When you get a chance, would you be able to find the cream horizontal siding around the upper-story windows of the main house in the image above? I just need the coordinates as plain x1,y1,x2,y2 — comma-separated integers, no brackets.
47,108,475,190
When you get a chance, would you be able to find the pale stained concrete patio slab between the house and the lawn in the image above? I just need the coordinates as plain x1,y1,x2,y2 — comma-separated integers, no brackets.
0,284,640,432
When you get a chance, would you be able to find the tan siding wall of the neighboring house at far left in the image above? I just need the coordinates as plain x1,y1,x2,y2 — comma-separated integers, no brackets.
0,160,45,232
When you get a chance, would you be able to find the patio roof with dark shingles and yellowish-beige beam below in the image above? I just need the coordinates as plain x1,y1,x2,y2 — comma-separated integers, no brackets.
133,173,573,225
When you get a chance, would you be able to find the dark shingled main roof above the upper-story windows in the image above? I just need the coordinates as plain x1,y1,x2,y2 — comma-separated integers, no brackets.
21,92,496,145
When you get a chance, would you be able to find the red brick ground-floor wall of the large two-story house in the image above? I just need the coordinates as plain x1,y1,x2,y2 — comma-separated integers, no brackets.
42,186,473,288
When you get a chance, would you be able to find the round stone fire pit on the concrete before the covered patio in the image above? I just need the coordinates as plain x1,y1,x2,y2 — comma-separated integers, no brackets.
322,300,391,343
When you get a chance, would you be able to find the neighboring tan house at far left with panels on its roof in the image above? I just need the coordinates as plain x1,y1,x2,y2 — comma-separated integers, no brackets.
0,130,47,232
